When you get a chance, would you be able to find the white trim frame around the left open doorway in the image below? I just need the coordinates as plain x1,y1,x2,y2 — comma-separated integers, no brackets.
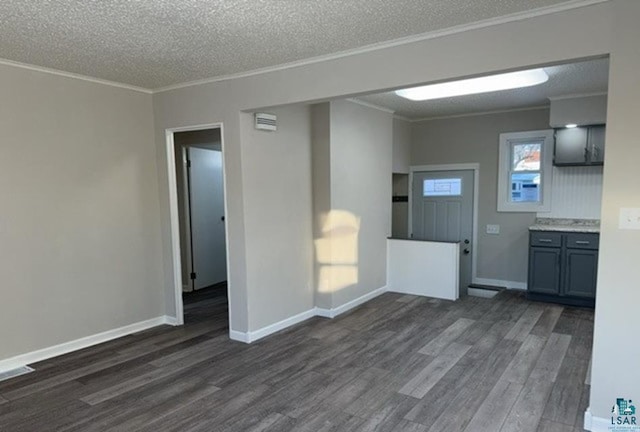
165,122,231,325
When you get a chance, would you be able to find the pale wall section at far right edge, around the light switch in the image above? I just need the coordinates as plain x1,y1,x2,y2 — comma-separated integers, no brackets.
591,1,640,418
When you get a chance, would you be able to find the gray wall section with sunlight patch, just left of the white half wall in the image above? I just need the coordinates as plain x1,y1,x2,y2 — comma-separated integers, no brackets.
331,100,393,307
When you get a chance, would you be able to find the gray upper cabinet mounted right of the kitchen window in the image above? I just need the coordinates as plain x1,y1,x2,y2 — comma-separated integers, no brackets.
553,125,606,166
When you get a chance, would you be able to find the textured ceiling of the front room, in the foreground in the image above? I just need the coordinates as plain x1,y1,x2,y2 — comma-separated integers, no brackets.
0,0,579,88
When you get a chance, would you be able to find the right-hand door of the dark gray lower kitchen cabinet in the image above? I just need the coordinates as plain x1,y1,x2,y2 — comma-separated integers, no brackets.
563,249,598,298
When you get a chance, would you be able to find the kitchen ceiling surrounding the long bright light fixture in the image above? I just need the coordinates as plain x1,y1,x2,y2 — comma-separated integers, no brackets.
357,58,609,119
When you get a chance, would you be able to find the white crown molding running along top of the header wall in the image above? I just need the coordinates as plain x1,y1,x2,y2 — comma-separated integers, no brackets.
153,0,610,93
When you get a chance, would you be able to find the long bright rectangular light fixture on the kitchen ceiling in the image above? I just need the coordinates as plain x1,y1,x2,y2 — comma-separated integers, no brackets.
396,69,549,101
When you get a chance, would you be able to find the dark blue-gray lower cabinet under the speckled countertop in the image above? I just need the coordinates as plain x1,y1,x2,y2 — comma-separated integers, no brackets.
527,231,599,307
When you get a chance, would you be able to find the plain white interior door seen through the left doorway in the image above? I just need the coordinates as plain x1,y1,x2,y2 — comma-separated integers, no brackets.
188,147,227,289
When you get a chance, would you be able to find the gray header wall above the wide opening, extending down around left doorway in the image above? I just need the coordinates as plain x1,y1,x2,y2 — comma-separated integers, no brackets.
153,3,613,332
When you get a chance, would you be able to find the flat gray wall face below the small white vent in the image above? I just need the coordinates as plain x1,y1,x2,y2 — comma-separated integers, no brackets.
240,106,314,331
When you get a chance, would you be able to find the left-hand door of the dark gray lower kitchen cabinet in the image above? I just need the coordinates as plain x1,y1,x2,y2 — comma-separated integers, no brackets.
528,247,562,295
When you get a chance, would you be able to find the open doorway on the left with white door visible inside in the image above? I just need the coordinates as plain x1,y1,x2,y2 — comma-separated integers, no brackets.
167,124,228,325
